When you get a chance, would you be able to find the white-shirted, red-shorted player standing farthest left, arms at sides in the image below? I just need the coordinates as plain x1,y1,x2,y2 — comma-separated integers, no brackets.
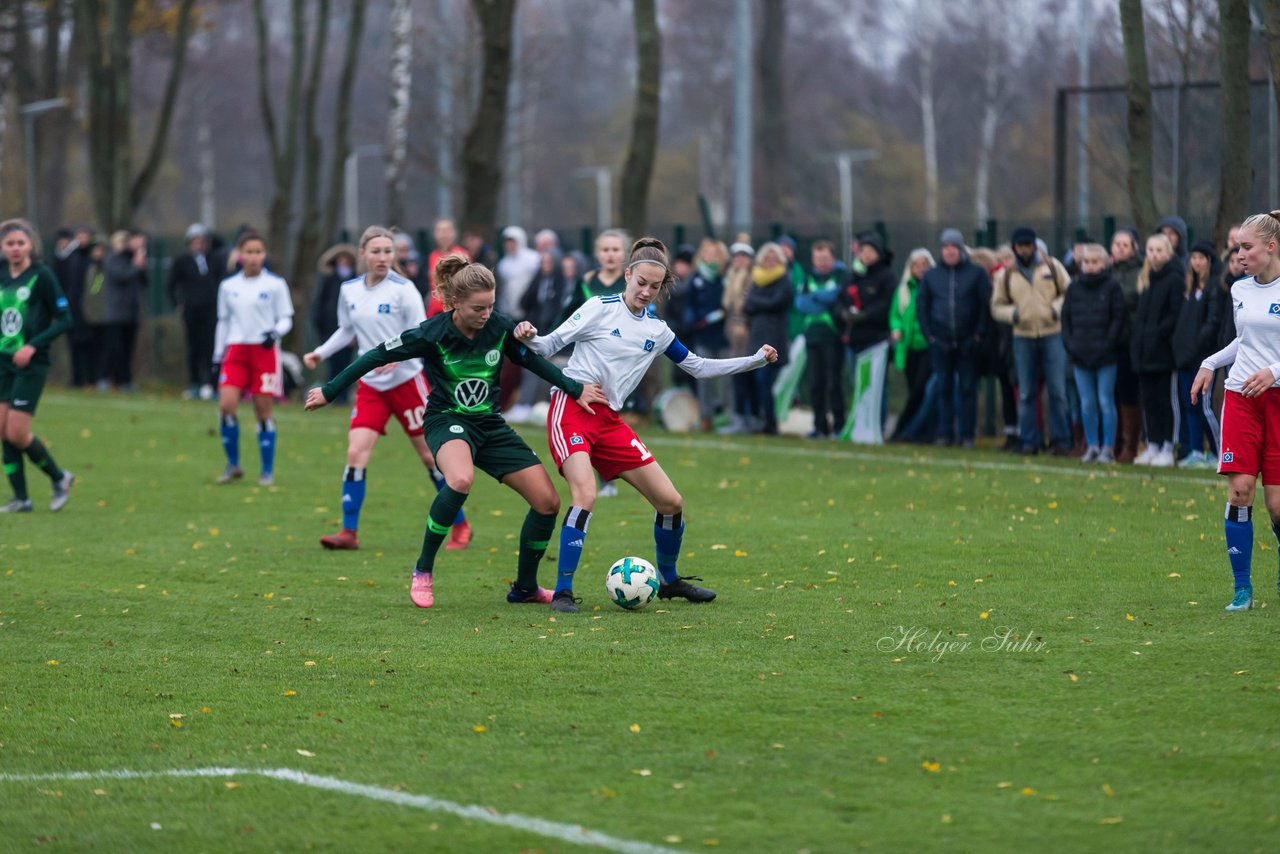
212,232,293,487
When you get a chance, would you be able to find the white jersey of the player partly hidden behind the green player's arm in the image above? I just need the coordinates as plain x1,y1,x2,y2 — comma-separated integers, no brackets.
316,270,426,392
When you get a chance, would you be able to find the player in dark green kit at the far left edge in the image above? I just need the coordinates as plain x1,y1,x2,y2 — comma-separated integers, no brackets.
0,219,76,513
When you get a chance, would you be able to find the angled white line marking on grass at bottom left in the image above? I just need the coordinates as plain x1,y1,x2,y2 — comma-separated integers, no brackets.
0,768,678,854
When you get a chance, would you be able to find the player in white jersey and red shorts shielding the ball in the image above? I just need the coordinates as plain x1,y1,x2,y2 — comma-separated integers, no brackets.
515,237,778,612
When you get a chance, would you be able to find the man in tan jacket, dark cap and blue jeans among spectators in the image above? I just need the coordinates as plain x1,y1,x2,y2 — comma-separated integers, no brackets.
991,227,1071,457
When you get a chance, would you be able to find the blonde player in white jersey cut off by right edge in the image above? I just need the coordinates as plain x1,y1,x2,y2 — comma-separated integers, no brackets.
1190,211,1280,611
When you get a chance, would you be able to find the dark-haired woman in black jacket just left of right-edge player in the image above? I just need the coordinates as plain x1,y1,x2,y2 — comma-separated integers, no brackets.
1174,241,1230,469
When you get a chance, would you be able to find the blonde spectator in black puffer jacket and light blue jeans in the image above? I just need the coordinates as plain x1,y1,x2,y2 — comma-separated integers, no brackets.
1062,243,1129,465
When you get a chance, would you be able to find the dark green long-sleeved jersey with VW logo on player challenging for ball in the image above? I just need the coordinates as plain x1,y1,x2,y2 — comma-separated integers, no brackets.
321,311,582,415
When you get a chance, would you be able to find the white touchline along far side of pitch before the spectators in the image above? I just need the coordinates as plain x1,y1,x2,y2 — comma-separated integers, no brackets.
52,393,1219,487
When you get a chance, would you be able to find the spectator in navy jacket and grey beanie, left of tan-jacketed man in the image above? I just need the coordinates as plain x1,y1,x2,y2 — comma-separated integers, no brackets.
915,228,991,448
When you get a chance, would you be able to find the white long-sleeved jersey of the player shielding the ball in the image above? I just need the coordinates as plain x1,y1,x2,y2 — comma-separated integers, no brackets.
527,293,765,411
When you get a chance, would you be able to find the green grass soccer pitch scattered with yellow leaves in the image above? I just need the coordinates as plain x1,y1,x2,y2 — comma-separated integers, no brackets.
0,392,1280,851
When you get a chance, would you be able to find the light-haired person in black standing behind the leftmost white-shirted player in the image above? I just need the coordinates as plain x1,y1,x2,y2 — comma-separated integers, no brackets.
168,223,227,401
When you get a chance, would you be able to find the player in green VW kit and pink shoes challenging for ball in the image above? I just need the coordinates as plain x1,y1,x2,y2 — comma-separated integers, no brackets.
306,255,605,608
